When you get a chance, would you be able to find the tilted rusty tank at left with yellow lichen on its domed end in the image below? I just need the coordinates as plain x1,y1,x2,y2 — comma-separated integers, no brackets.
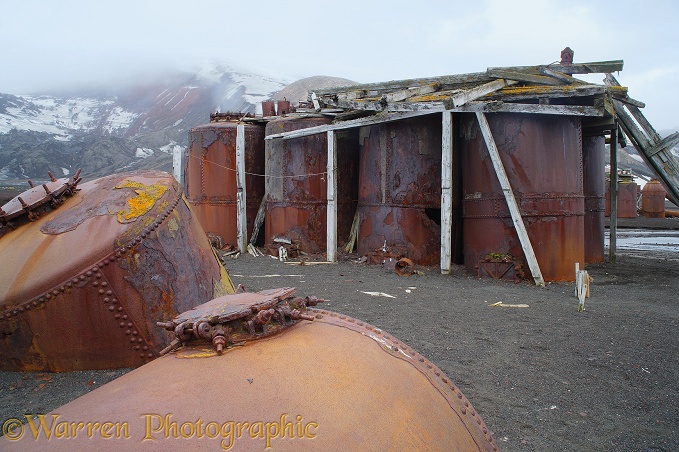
0,171,234,371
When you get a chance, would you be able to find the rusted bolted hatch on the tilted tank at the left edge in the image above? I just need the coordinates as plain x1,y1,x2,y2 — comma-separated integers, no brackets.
0,170,82,237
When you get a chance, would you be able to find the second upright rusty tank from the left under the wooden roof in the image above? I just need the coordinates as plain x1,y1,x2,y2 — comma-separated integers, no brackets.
265,116,359,253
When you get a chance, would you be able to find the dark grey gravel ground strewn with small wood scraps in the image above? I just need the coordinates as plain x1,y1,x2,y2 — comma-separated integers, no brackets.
0,222,679,451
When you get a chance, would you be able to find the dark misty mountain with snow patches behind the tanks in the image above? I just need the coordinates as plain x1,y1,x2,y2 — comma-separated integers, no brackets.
0,64,289,180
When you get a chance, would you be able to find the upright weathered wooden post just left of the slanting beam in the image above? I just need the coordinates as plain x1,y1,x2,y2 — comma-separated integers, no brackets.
441,111,454,275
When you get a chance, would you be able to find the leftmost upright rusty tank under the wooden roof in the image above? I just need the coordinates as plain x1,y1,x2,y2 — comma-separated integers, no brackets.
190,122,264,245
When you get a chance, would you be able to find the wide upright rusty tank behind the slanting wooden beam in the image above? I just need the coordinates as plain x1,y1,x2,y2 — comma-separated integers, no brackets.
461,113,585,281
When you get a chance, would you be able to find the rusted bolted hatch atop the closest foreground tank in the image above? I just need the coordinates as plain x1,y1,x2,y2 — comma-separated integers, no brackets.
157,285,325,355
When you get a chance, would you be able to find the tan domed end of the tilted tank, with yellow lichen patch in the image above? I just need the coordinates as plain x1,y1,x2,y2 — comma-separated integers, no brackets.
0,171,181,307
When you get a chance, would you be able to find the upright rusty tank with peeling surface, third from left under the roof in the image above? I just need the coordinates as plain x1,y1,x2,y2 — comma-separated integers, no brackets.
358,115,441,265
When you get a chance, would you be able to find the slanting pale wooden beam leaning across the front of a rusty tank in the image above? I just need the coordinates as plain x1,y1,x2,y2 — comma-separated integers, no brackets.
476,112,545,287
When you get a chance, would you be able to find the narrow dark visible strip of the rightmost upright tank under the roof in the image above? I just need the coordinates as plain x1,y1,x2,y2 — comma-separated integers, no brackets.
582,136,606,263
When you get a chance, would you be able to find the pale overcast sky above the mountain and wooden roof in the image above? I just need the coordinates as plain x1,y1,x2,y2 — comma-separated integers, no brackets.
0,0,679,130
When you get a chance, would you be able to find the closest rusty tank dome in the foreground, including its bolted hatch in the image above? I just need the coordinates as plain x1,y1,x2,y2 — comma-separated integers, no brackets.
0,288,497,451
